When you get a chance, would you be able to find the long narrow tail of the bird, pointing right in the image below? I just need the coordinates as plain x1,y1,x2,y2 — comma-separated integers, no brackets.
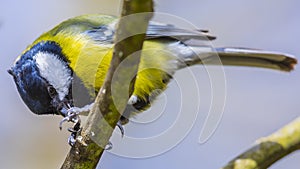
185,47,297,72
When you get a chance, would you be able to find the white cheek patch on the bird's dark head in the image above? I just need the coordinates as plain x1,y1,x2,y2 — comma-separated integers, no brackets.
33,52,72,100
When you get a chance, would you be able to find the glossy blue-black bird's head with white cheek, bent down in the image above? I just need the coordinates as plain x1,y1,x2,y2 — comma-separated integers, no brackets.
8,41,73,115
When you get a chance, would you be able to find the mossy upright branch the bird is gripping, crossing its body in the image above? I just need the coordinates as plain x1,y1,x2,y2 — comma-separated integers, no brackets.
61,0,153,169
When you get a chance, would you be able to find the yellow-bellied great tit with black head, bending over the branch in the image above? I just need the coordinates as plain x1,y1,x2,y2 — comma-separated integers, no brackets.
8,14,297,144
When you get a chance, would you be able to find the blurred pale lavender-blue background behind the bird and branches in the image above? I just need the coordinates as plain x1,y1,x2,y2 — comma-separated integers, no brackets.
0,0,300,169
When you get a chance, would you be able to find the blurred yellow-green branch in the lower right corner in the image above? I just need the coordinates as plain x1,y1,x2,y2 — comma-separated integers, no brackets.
222,117,300,169
